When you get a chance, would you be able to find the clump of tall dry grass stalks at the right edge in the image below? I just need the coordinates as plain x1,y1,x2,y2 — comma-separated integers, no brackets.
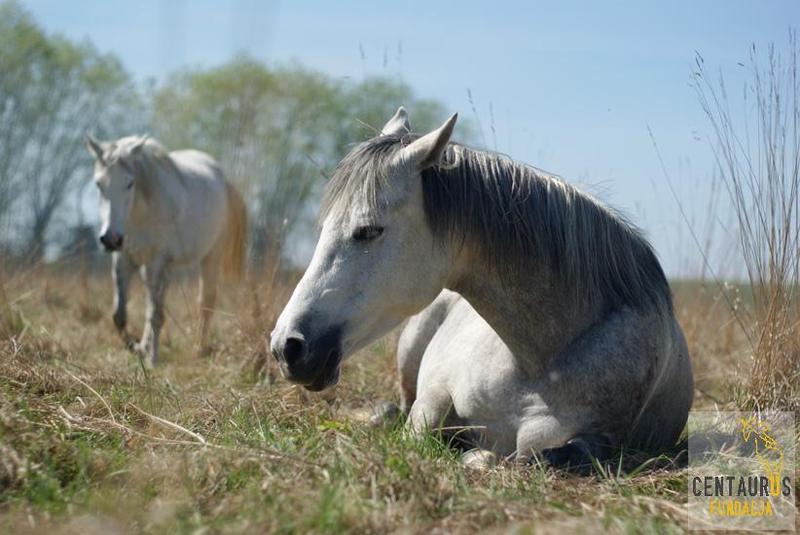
694,33,800,408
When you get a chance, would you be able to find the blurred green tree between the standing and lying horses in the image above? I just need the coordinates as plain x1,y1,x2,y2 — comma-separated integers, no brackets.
153,57,460,266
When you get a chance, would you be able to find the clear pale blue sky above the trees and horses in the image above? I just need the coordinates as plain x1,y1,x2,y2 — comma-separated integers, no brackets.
23,0,800,275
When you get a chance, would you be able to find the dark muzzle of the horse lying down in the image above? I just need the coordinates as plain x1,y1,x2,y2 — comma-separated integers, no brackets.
270,327,342,392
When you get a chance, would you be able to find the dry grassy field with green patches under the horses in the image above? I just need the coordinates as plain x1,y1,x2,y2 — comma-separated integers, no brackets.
0,262,788,533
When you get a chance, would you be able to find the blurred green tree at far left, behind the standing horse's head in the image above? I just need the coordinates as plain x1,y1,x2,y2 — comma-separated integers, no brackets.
0,2,141,259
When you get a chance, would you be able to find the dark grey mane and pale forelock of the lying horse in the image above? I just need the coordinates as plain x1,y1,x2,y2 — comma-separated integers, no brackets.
320,134,672,310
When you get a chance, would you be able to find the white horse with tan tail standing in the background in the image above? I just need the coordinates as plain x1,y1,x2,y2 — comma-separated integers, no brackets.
86,136,247,366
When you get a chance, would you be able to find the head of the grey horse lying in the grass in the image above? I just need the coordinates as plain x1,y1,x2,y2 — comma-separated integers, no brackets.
271,108,457,390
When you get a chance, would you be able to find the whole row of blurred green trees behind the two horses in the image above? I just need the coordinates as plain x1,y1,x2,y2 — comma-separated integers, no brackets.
0,1,460,261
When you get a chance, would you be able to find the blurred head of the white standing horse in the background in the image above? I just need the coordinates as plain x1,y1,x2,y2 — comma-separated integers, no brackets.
85,136,147,251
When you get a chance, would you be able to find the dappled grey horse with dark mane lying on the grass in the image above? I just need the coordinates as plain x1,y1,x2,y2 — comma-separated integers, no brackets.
271,108,693,464
